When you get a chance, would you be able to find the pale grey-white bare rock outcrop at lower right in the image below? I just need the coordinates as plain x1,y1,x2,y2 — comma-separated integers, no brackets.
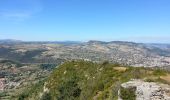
118,80,170,100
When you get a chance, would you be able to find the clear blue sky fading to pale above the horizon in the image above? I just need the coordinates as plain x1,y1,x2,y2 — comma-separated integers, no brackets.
0,0,170,43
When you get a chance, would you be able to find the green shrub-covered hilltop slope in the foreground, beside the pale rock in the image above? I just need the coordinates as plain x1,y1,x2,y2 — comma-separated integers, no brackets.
19,61,170,100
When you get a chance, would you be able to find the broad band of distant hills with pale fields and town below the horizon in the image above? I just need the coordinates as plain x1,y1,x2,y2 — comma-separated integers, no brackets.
0,40,170,67
